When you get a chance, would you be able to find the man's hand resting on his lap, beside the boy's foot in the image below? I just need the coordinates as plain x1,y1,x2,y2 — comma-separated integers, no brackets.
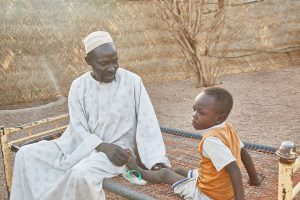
96,143,130,167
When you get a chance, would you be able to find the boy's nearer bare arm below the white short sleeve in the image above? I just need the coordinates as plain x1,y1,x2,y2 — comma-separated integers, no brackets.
224,161,245,200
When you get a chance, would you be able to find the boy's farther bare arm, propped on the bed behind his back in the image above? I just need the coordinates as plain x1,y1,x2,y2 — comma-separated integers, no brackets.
241,147,262,186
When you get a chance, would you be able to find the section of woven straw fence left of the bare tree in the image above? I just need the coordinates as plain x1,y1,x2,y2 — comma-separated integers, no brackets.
0,0,184,106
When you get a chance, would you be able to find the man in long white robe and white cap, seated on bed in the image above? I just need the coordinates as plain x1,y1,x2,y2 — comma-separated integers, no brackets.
11,31,170,200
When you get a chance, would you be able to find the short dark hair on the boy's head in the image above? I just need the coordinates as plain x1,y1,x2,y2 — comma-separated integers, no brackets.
204,87,233,116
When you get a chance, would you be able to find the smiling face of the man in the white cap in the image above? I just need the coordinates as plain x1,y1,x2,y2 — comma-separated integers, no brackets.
85,43,119,83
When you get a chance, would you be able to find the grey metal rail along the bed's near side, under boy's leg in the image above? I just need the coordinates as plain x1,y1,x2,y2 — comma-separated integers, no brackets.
103,179,155,200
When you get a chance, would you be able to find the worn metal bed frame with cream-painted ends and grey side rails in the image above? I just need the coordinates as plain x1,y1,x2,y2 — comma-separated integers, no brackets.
0,114,300,200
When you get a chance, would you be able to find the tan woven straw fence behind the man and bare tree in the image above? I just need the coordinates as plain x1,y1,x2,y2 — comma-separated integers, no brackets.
0,0,300,107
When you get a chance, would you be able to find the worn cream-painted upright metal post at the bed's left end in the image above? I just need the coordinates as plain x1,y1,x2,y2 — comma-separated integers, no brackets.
0,127,12,194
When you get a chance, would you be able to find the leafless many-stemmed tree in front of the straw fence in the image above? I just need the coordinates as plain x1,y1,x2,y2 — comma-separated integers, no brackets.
157,0,225,87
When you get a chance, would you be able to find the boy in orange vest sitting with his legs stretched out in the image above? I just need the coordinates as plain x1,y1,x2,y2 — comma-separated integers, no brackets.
127,87,262,200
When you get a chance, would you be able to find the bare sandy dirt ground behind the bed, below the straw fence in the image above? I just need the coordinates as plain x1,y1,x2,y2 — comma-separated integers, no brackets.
0,67,300,200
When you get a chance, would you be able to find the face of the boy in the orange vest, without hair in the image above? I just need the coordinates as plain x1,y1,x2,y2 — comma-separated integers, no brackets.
192,92,220,130
